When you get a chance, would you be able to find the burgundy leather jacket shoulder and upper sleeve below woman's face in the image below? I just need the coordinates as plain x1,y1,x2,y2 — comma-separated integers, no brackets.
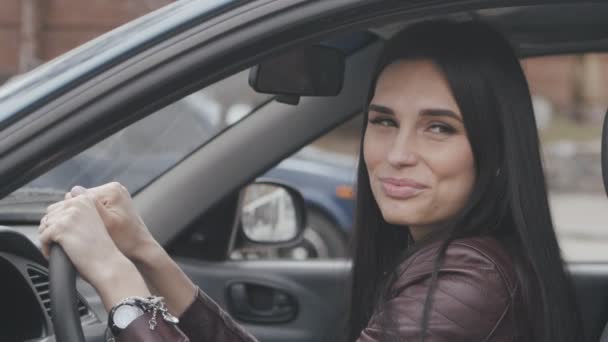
358,240,516,342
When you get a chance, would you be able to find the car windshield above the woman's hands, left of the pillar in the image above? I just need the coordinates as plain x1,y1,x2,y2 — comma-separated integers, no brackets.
0,71,271,205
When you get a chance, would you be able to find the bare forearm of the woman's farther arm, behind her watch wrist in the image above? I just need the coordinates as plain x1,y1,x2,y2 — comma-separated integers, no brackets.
132,241,197,317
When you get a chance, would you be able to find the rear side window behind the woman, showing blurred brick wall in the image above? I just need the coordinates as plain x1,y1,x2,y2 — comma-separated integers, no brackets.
523,53,608,261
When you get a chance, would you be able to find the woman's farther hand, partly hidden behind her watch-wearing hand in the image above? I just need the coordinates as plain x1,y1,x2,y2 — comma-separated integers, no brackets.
65,182,160,263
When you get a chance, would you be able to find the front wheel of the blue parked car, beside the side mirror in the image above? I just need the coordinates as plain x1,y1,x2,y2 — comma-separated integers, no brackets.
279,209,348,260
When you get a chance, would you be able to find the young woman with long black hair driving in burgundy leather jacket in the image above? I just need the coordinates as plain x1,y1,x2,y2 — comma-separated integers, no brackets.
40,22,582,342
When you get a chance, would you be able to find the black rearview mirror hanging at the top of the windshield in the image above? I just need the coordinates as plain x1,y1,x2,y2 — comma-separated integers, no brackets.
249,45,345,96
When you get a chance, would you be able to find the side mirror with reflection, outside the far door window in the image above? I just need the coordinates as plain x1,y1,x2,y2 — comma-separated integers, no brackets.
240,181,306,247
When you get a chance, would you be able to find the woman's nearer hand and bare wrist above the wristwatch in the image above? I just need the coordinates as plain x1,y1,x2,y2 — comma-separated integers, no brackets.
39,191,150,308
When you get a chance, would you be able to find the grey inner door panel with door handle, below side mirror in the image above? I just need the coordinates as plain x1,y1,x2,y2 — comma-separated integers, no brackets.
176,258,350,342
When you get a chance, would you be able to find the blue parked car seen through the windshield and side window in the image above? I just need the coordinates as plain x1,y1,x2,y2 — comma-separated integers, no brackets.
30,73,356,259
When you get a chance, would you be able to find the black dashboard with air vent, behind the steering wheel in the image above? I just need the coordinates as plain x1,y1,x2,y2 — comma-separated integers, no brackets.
0,226,105,342
